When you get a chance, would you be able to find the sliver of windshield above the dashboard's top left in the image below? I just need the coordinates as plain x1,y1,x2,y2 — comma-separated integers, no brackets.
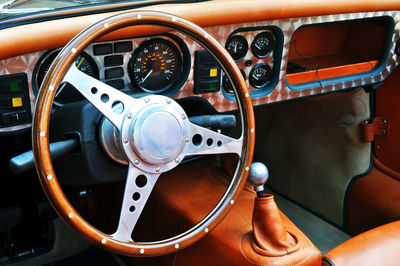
0,0,150,19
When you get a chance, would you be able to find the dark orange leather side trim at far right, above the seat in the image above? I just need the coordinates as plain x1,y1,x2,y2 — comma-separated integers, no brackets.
347,67,400,233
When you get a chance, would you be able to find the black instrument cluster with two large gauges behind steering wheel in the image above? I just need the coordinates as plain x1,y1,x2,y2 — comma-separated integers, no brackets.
32,34,190,106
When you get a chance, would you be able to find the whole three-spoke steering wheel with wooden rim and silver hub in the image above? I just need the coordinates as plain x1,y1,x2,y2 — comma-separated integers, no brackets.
32,11,255,256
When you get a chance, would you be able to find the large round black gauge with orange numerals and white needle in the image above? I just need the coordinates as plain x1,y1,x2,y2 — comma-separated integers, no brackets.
128,38,182,93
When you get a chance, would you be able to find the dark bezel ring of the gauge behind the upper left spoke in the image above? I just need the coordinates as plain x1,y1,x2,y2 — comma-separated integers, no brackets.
32,49,100,107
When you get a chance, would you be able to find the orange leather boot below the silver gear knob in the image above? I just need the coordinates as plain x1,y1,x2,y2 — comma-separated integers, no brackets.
252,195,297,256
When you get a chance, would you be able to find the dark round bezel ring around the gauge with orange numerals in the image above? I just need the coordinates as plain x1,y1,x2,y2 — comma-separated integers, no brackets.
127,37,183,93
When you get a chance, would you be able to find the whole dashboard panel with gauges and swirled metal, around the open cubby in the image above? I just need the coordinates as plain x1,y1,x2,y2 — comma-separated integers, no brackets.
0,11,400,132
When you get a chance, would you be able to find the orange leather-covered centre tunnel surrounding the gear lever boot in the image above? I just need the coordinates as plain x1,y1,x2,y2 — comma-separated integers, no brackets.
146,160,321,266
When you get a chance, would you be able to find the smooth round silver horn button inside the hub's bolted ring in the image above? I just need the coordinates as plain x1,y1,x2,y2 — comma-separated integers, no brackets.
131,107,184,164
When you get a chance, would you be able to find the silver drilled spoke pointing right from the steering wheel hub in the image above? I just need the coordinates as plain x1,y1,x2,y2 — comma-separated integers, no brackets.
186,123,243,156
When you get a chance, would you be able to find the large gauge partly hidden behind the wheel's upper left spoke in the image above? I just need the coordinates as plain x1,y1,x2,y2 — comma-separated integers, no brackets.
36,51,99,106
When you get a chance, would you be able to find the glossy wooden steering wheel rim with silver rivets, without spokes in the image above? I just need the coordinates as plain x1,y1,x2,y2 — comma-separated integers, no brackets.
32,11,255,256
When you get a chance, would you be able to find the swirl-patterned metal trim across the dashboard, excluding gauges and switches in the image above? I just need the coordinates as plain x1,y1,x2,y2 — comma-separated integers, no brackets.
0,11,400,132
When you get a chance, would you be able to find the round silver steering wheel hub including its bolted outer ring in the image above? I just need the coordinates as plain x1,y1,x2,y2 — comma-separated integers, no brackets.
121,95,191,173
